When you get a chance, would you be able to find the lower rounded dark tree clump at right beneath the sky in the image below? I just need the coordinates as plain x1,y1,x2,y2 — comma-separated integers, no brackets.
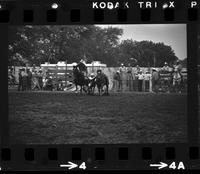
116,40,178,66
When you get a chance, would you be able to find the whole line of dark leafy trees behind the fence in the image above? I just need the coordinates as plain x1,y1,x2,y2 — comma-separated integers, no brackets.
8,25,184,67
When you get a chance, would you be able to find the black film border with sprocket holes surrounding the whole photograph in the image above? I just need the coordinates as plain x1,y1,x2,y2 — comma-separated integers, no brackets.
0,1,200,170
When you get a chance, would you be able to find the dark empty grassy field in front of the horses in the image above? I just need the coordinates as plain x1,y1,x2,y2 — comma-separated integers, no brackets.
9,92,187,144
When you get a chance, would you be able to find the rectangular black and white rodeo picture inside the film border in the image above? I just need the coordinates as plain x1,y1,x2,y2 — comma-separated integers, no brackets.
8,24,188,144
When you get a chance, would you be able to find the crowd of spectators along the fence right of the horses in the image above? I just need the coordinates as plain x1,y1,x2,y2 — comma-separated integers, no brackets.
112,61,186,92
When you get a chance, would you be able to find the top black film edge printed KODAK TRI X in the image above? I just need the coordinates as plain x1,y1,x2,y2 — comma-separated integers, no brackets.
0,0,199,25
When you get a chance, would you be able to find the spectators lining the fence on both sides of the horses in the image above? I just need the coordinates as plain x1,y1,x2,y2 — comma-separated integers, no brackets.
8,61,186,92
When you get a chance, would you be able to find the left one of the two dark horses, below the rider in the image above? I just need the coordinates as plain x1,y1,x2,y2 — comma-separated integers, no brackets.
73,66,89,94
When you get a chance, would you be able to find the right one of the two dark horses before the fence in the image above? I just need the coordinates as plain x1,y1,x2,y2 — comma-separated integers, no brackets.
95,70,109,95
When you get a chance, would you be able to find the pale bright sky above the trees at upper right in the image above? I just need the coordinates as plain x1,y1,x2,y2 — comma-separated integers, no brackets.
97,24,187,59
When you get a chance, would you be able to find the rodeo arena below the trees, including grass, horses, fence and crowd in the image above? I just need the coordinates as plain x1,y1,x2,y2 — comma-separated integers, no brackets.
8,59,191,144
